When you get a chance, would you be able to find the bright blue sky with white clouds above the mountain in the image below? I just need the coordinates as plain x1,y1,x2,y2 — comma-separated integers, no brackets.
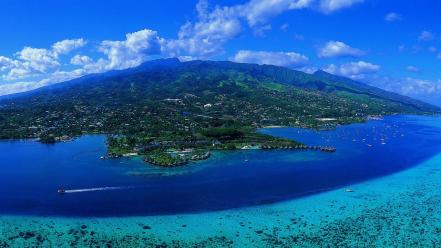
0,0,441,106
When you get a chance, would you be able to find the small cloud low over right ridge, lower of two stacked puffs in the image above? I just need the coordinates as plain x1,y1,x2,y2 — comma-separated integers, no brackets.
324,61,380,79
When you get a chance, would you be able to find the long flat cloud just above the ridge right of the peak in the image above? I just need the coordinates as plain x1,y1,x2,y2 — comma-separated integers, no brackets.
232,50,309,68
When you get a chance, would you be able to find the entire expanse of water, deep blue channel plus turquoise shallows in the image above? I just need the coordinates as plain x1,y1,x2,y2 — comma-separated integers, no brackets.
0,116,441,246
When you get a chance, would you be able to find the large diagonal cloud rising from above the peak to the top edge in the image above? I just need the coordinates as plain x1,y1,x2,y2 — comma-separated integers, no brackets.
162,0,363,58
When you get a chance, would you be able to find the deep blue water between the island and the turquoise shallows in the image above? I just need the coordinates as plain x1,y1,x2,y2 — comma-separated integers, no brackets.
0,116,441,216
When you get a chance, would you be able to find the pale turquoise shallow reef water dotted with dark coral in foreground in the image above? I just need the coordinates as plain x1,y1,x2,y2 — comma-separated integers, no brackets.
0,154,441,246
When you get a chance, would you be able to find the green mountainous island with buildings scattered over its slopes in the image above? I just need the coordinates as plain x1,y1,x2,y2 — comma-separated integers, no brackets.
0,59,434,167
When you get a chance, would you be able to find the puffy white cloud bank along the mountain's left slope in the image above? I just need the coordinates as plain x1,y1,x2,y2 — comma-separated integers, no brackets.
0,30,160,95
